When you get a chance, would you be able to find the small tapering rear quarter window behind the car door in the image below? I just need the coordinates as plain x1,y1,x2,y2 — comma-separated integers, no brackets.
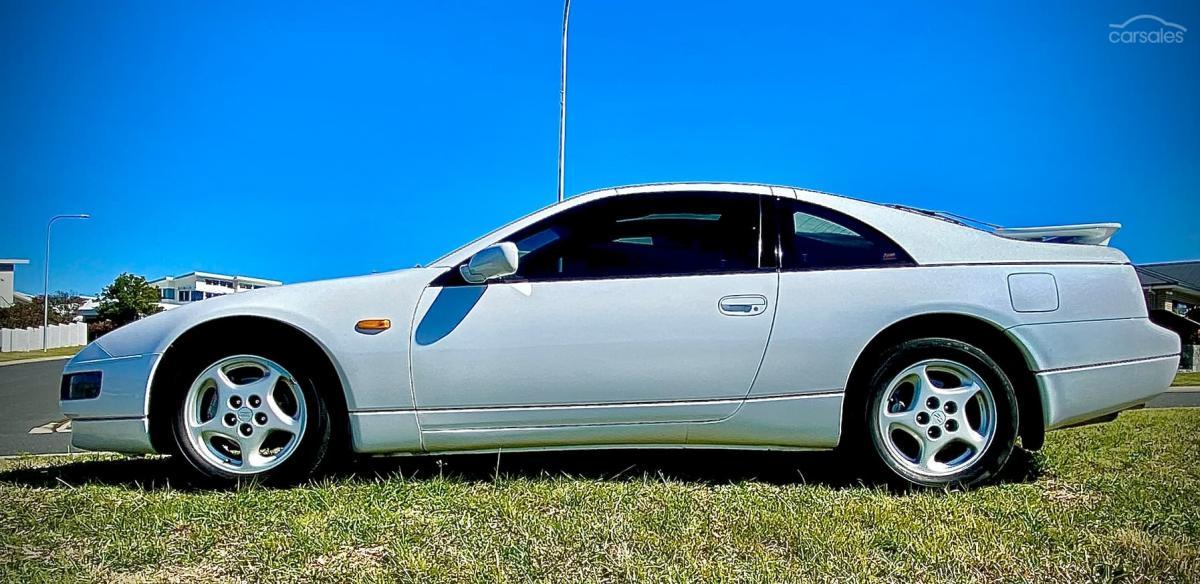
780,201,912,270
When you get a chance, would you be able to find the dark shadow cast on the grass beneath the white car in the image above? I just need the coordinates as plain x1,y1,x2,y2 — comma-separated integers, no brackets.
0,448,1043,493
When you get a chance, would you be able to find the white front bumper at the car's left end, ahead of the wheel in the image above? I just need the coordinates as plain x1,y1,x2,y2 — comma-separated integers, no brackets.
59,350,161,453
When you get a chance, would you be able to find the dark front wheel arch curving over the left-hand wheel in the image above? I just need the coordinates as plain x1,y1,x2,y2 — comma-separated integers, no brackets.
146,314,349,453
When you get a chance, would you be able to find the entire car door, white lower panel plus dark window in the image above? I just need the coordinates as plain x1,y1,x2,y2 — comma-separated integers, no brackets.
412,193,778,448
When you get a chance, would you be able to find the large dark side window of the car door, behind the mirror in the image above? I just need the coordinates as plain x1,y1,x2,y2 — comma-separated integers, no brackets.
509,193,760,281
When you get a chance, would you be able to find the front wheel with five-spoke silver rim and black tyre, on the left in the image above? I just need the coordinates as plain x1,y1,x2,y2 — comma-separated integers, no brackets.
172,343,335,484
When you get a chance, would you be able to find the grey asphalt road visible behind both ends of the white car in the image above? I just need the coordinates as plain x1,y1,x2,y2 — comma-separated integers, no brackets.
0,359,1200,456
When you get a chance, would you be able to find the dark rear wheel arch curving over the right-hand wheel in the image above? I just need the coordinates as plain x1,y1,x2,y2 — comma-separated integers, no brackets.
841,312,1045,450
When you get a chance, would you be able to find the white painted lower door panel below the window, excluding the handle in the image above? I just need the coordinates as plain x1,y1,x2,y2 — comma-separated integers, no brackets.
412,271,779,431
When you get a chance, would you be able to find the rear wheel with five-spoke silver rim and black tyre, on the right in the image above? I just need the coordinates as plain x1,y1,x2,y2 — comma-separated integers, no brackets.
859,338,1020,488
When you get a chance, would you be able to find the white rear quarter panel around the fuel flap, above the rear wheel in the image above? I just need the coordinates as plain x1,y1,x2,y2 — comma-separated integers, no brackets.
750,264,1148,397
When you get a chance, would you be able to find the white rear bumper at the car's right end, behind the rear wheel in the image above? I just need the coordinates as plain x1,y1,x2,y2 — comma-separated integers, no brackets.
1037,355,1180,429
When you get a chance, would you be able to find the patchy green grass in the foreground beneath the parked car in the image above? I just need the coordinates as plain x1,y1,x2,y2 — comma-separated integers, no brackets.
0,409,1200,584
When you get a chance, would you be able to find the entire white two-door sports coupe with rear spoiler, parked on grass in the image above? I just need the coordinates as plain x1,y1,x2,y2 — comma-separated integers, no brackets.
61,183,1180,487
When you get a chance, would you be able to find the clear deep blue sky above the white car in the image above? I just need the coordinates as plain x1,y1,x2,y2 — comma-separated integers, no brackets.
0,0,1200,293
